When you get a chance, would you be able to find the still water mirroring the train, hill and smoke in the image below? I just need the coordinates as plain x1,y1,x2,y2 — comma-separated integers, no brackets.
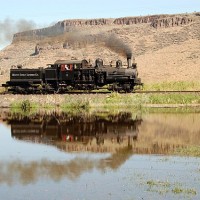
0,112,200,200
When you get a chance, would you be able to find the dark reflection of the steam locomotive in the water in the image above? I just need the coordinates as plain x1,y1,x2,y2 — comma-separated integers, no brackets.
9,112,142,152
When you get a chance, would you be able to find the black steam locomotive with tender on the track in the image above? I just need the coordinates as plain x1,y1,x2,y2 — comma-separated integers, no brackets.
2,57,142,94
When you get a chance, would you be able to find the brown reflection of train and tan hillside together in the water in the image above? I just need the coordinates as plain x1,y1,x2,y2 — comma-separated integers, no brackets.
1,112,200,154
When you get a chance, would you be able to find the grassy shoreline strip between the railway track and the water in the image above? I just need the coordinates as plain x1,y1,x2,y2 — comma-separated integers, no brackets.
0,93,200,109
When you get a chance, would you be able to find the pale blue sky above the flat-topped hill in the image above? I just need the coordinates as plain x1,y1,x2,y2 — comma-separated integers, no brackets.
0,0,200,47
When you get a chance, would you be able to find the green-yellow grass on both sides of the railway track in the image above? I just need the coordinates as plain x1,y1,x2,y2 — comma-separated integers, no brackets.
0,82,200,110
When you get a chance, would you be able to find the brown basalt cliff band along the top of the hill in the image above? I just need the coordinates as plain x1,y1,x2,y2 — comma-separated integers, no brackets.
13,15,193,42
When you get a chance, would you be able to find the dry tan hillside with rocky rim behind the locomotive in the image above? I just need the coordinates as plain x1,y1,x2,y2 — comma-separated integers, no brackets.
0,13,200,83
